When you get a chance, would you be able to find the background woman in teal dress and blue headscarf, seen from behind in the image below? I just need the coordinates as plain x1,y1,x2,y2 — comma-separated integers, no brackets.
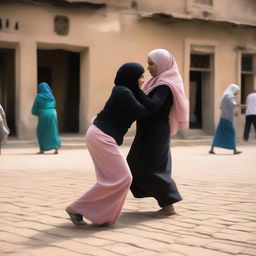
32,83,61,154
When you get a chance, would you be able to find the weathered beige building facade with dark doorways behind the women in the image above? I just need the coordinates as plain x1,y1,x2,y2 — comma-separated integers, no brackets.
0,0,256,139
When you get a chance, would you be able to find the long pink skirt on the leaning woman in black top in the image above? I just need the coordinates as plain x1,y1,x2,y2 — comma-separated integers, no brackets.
69,125,132,224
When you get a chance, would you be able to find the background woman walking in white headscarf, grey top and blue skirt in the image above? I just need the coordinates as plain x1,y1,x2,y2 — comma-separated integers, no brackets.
209,84,242,154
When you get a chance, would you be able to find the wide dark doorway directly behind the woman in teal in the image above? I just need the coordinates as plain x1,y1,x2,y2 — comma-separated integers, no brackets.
37,49,80,133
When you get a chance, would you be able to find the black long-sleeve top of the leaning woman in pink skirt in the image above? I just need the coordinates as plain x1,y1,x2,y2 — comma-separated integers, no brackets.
93,86,169,145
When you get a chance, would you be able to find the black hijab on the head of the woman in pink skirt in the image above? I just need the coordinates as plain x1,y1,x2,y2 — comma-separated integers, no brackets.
114,62,145,94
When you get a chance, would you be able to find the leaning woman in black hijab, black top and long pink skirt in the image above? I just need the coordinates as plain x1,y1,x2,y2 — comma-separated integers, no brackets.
66,63,154,225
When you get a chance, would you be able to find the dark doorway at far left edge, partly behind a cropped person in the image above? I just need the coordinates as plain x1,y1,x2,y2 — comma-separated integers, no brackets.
0,48,16,135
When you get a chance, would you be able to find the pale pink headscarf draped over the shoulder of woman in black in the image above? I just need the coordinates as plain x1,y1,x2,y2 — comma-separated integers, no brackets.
143,49,189,134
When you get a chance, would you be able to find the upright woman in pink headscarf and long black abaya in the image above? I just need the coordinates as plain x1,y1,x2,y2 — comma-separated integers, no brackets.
127,49,188,216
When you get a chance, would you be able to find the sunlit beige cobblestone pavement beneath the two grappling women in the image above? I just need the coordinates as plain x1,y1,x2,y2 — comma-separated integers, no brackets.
0,141,256,256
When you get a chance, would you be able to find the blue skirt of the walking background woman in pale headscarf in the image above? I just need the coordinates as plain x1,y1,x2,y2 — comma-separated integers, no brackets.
212,118,236,149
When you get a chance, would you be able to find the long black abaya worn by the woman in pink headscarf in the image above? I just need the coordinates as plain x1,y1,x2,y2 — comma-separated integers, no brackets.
127,85,182,207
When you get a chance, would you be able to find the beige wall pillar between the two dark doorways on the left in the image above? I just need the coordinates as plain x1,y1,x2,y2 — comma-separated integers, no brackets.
16,40,37,140
